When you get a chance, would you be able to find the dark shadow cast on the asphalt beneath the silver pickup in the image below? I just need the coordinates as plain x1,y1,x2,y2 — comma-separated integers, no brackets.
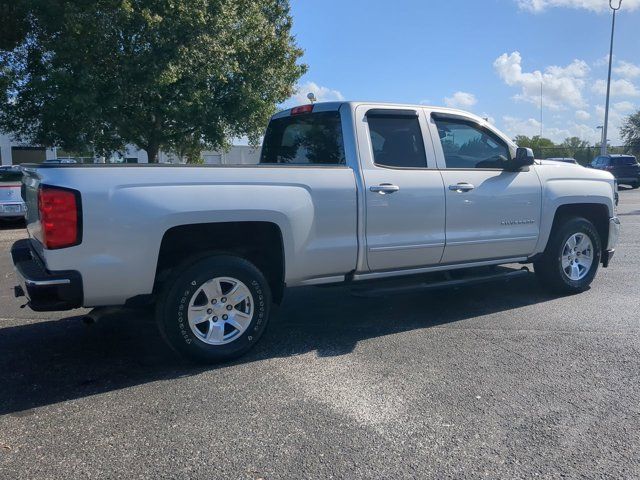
0,276,556,416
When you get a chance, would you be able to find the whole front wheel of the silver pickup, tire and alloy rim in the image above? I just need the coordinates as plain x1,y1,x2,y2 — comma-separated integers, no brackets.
534,217,602,293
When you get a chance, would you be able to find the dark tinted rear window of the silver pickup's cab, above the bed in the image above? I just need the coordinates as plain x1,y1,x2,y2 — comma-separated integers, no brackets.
260,112,346,165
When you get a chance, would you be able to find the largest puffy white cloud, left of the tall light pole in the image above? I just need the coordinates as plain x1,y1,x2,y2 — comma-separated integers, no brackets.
493,51,592,110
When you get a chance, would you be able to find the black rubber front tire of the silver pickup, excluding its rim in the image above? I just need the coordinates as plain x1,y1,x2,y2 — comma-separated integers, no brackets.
533,217,602,294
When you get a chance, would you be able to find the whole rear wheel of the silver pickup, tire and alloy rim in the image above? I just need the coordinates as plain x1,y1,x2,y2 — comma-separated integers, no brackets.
156,255,271,363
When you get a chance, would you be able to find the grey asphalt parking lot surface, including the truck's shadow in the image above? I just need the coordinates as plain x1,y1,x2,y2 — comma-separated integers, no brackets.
0,190,640,479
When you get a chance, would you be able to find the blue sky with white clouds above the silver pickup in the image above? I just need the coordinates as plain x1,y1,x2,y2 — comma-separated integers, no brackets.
291,0,640,144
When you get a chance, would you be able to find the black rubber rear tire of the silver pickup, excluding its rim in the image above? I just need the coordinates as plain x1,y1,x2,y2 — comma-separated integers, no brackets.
156,255,271,363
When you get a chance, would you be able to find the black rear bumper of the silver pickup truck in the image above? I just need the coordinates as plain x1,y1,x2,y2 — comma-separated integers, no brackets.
11,240,83,312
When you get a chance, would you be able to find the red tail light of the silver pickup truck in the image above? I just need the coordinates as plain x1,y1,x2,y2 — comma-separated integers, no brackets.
38,185,82,250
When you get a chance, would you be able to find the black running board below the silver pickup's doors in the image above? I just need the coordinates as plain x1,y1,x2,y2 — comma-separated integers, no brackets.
351,267,531,298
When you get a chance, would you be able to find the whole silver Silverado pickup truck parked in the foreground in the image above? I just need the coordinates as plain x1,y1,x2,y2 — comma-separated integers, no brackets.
12,102,619,361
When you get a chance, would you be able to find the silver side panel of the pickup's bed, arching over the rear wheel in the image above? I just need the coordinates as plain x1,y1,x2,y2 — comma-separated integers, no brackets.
23,166,358,306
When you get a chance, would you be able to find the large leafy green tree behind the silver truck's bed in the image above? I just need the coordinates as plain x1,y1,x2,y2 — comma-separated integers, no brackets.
0,0,306,162
